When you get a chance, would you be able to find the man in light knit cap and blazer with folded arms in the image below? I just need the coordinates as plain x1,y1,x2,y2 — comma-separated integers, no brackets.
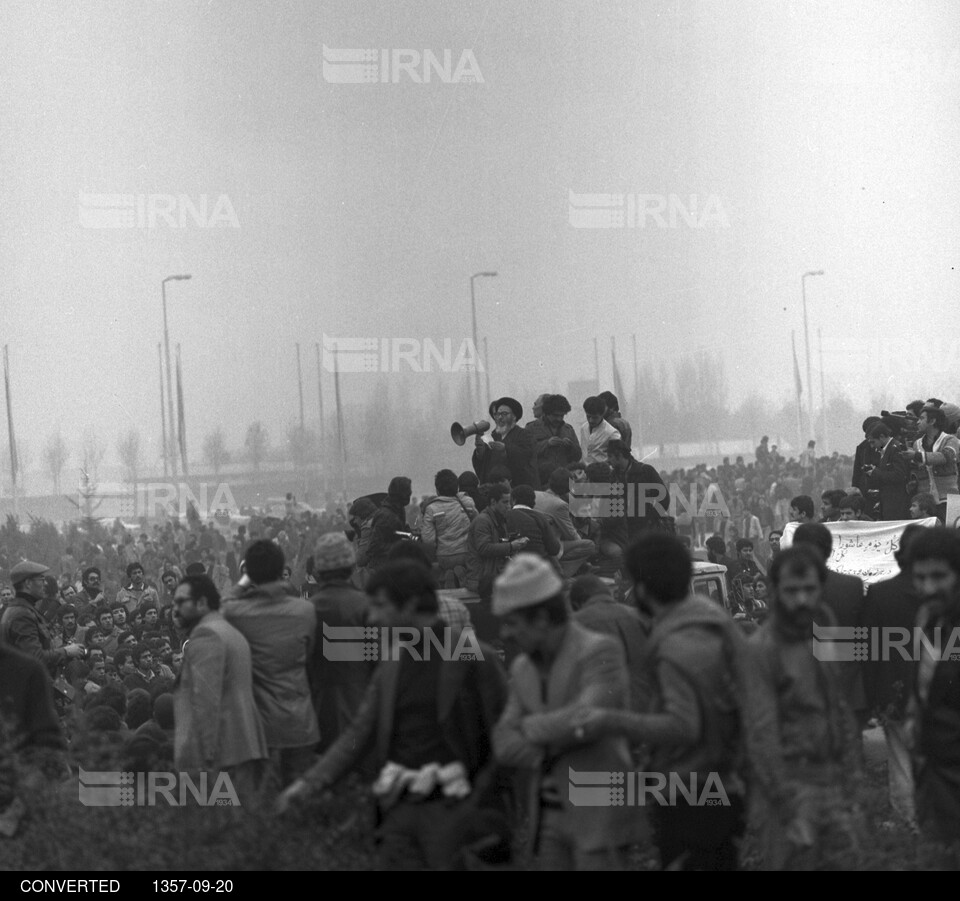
493,554,644,870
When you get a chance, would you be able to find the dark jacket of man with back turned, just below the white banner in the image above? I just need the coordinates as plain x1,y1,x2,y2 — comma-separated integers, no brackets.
863,570,920,721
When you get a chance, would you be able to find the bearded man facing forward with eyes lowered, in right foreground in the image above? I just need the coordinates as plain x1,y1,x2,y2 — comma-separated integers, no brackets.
746,544,861,870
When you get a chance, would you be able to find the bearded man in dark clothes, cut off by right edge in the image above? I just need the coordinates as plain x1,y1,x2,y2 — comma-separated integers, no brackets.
909,529,960,843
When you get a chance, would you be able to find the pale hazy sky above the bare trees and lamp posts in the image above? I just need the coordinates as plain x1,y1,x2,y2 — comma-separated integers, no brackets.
0,0,960,474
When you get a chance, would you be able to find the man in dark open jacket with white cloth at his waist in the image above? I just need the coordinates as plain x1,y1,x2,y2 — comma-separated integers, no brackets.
278,560,506,870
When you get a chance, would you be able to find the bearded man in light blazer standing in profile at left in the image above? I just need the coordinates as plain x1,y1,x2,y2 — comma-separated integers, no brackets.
174,576,269,806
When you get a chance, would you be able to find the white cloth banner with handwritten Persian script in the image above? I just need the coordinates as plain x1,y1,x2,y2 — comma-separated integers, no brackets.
780,516,939,585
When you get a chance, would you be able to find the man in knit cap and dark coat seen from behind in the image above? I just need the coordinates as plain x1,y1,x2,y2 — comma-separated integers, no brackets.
309,532,373,751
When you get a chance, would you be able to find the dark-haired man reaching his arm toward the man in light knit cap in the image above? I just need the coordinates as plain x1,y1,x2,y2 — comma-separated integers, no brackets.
568,532,750,870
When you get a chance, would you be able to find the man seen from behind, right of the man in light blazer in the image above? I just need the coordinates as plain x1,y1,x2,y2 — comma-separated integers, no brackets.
222,540,320,790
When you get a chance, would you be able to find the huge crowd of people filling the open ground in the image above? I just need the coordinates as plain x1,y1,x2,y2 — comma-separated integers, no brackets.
0,392,960,869
